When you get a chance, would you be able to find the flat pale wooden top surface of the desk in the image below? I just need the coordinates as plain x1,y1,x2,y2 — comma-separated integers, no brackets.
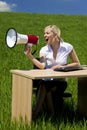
10,69,87,79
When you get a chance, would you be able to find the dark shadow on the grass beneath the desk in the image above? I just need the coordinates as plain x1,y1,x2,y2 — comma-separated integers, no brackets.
35,100,86,125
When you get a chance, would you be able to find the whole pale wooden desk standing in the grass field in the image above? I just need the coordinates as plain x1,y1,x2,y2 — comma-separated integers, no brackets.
10,69,87,123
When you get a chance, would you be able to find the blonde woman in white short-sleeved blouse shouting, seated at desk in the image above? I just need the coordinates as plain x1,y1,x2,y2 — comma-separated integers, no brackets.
26,25,80,118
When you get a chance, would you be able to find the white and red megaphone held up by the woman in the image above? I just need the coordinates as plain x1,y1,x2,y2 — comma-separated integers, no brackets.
5,28,39,48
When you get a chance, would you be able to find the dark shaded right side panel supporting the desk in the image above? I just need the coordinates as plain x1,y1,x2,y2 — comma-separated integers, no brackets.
78,77,87,117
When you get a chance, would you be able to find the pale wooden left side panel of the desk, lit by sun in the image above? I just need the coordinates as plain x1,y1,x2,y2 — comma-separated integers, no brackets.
12,74,32,123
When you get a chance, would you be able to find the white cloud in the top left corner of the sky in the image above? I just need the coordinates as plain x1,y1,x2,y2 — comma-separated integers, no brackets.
0,1,16,12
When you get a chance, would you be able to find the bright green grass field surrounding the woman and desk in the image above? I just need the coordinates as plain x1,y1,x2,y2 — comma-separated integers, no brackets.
0,13,87,130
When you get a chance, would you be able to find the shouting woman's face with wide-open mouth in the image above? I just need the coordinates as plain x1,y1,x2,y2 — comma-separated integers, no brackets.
44,28,55,44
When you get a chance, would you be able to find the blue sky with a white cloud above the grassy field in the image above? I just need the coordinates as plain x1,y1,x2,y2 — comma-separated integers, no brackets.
0,0,87,15
